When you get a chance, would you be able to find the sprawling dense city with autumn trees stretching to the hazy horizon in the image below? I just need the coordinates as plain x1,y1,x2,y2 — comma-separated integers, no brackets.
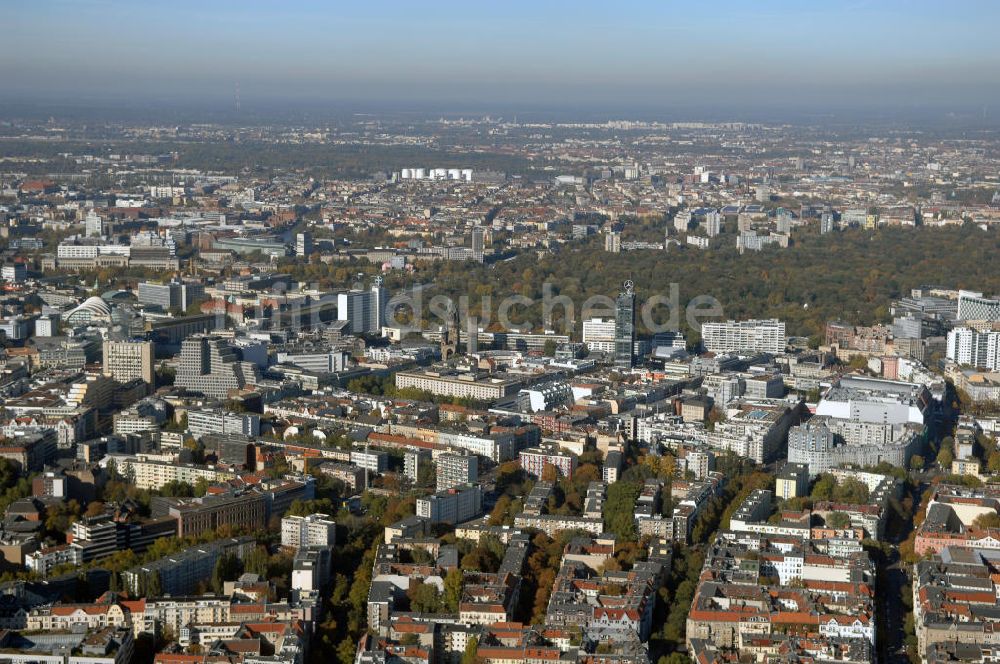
0,1,1000,664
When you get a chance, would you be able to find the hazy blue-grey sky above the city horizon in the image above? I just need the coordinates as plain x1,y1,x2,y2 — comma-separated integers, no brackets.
0,0,1000,113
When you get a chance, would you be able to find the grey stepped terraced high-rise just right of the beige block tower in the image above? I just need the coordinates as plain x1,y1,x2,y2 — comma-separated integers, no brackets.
174,334,260,399
